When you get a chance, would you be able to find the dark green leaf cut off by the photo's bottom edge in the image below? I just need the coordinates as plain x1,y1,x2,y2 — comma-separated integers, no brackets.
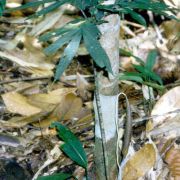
37,173,73,180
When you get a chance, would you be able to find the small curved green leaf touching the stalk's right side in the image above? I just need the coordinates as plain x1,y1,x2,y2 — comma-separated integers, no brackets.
119,72,143,84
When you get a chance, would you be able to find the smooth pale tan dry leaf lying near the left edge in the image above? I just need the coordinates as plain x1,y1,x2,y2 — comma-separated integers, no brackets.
2,92,41,116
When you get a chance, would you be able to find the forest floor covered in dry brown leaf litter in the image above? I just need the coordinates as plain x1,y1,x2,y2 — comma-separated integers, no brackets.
0,0,180,180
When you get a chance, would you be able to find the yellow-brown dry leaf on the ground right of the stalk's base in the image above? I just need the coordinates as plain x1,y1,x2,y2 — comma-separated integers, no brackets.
123,144,156,180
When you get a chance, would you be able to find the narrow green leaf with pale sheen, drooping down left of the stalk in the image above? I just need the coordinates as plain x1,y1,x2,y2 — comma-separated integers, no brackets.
54,31,82,81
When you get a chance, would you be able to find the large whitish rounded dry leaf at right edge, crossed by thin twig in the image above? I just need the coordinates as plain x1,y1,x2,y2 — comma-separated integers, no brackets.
147,86,180,151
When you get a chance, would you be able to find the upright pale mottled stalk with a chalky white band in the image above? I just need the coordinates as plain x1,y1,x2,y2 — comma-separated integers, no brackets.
94,0,120,180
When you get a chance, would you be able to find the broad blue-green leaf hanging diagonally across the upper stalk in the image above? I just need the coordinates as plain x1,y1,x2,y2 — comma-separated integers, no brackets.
82,23,112,73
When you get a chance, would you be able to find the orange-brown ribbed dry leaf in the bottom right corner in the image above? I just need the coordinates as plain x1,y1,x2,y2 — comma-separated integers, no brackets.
165,145,180,180
